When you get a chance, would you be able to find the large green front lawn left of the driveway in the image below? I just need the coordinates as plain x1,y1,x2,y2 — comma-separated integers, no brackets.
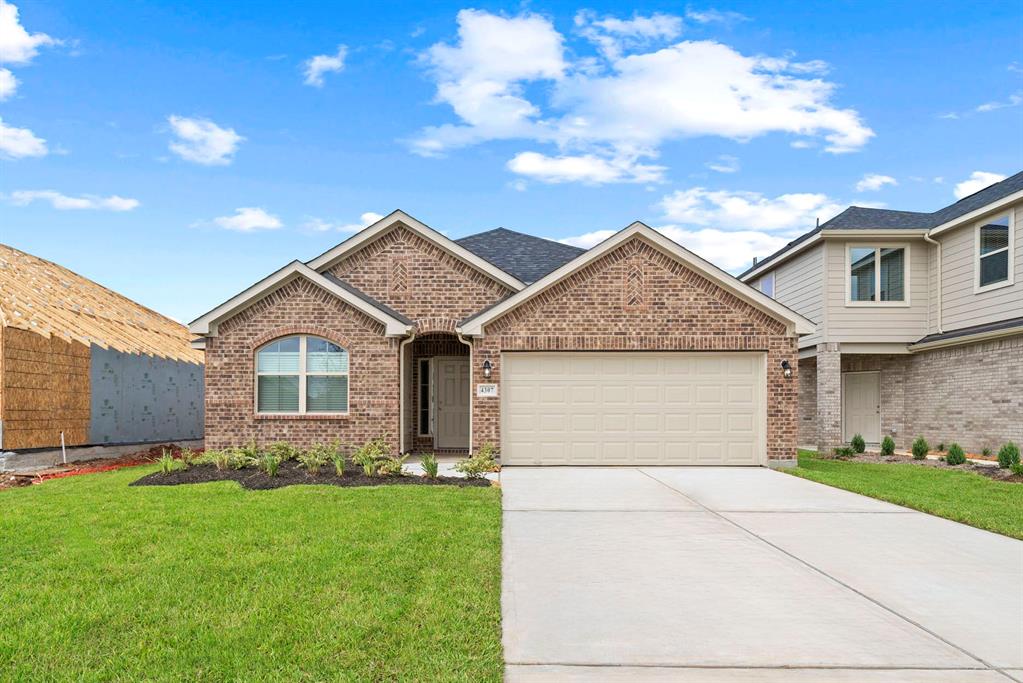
0,467,502,681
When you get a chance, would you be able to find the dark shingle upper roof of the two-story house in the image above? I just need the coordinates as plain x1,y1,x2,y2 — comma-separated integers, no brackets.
739,171,1023,278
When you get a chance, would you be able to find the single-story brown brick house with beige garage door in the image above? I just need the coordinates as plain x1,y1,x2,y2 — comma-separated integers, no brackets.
190,211,812,465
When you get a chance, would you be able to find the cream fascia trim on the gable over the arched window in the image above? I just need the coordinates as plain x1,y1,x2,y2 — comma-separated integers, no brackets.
188,261,410,336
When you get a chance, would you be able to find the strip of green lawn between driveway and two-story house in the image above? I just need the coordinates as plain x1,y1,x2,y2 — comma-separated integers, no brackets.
784,451,1023,539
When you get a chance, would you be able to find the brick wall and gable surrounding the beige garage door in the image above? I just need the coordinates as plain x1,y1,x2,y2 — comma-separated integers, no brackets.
473,237,799,459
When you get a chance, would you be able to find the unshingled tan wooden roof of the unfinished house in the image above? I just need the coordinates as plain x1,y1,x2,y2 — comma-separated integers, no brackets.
0,244,203,363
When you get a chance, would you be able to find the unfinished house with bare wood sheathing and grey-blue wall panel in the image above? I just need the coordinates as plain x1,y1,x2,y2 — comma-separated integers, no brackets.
0,244,204,450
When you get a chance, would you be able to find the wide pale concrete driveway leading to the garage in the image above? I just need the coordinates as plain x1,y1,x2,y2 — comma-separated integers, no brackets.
501,467,1023,683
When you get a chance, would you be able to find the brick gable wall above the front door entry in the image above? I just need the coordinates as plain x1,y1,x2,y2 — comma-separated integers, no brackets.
327,225,512,331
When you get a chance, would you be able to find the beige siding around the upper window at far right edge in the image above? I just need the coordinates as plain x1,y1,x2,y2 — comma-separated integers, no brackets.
937,203,1023,331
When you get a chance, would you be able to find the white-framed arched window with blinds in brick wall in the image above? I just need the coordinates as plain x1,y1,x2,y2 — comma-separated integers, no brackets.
256,335,348,415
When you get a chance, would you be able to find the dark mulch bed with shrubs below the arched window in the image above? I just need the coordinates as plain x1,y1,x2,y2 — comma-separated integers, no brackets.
131,461,491,491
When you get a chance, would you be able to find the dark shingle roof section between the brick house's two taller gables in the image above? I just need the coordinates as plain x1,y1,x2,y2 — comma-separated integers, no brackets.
455,228,586,284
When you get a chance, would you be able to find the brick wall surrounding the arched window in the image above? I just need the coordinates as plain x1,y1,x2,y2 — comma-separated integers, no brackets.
206,279,398,448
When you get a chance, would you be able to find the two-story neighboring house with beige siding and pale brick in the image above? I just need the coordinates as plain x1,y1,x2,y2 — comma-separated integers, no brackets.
740,173,1023,452
